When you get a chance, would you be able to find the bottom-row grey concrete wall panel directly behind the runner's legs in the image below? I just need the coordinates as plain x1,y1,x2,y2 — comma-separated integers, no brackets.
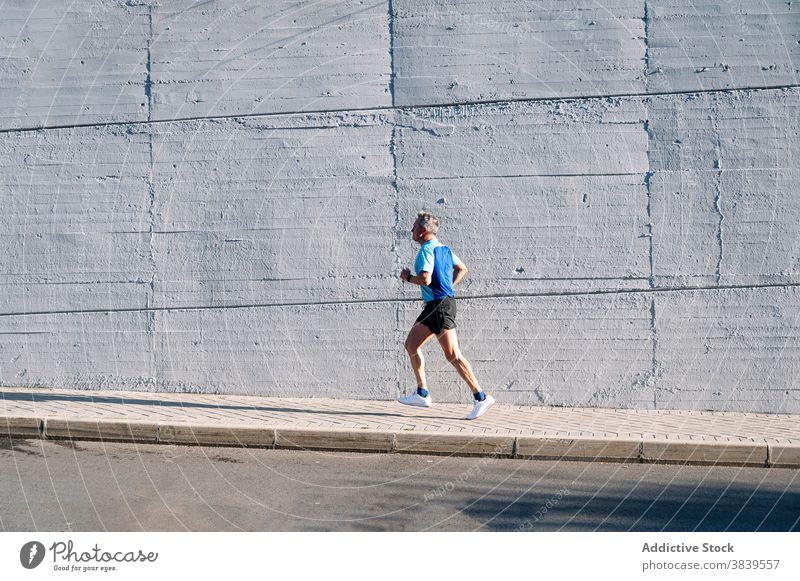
400,294,654,408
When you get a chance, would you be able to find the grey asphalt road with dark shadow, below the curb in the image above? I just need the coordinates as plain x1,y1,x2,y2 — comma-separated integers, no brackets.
0,439,800,531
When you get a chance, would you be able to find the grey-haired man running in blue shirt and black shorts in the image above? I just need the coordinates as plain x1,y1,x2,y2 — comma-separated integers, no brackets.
397,212,494,420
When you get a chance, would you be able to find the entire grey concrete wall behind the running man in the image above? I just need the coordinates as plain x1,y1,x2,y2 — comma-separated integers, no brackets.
0,0,800,413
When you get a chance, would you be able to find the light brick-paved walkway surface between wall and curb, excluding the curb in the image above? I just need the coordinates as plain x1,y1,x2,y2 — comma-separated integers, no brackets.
0,388,800,444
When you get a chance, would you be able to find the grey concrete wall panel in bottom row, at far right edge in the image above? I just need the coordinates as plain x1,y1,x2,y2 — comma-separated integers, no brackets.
654,287,800,412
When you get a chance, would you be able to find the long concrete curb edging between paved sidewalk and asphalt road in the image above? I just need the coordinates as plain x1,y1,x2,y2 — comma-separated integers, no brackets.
0,417,800,468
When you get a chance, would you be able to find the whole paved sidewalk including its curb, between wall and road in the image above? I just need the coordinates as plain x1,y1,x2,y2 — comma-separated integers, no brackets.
0,387,800,468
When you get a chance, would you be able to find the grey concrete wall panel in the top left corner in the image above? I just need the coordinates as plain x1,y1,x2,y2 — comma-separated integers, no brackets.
0,0,151,129
